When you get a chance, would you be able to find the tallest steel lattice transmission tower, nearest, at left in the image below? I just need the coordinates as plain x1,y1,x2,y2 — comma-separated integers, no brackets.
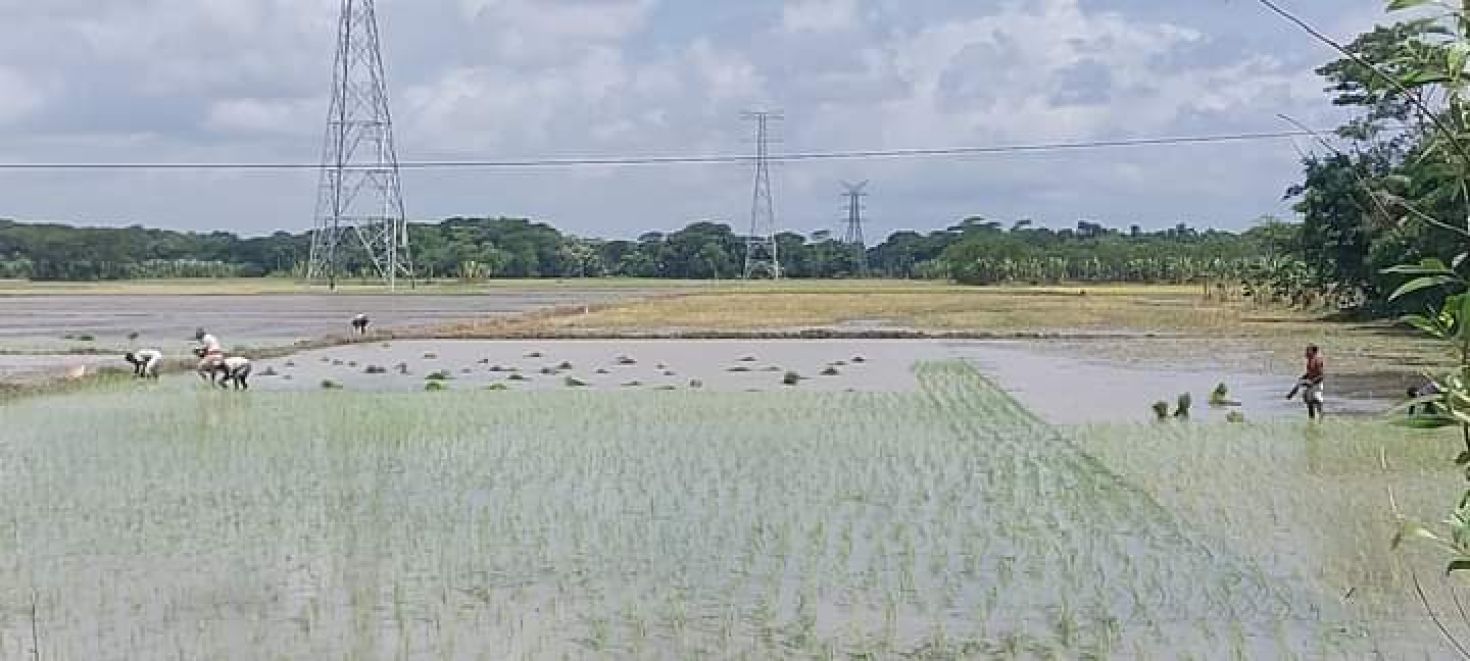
307,0,413,289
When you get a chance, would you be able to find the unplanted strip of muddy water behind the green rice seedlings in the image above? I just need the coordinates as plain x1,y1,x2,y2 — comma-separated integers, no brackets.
246,341,1402,425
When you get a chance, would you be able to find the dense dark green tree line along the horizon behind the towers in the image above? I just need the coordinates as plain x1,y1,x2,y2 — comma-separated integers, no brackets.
0,212,1294,285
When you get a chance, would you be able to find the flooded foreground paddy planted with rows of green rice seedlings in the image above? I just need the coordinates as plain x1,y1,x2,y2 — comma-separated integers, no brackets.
0,364,1454,660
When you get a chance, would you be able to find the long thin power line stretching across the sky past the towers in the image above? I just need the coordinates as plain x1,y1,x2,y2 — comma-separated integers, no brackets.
0,129,1330,170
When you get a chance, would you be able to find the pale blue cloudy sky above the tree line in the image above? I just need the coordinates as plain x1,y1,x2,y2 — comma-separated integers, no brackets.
0,0,1383,238
